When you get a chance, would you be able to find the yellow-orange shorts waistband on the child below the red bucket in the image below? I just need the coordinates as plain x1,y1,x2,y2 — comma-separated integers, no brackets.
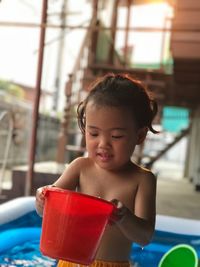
57,260,131,267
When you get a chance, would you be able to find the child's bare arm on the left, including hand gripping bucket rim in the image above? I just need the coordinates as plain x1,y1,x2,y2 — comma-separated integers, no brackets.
35,158,84,216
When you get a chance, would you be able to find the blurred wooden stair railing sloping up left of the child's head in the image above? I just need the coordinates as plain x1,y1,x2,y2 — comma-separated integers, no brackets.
57,20,94,163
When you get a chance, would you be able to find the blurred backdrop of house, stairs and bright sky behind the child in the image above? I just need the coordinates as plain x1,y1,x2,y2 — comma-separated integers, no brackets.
0,0,200,219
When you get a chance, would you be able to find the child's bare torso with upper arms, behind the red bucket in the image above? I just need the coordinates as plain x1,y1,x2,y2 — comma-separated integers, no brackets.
55,158,155,261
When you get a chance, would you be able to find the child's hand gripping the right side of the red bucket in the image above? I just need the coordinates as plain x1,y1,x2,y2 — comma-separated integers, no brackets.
110,199,128,224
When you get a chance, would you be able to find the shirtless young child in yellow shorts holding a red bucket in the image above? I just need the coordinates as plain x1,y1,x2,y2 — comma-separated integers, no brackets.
36,74,157,267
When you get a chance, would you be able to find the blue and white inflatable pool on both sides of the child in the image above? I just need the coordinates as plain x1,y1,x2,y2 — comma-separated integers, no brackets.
0,197,200,267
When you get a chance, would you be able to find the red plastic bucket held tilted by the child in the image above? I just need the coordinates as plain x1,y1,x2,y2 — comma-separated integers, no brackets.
40,188,115,265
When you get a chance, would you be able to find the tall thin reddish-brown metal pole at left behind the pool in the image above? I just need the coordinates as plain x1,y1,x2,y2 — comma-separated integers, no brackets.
25,0,48,196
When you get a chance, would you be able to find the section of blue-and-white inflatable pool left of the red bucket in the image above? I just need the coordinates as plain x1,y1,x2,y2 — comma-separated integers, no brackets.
0,197,56,267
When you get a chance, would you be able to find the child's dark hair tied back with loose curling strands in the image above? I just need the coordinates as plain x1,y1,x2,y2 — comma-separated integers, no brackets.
77,73,158,133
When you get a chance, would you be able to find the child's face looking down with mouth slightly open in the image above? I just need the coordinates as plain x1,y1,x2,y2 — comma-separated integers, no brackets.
85,102,142,173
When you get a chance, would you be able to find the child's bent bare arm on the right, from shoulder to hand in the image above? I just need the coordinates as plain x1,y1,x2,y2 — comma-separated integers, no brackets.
111,172,156,246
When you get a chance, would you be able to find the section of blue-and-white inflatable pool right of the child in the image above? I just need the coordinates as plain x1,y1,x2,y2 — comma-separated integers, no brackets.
130,215,200,267
